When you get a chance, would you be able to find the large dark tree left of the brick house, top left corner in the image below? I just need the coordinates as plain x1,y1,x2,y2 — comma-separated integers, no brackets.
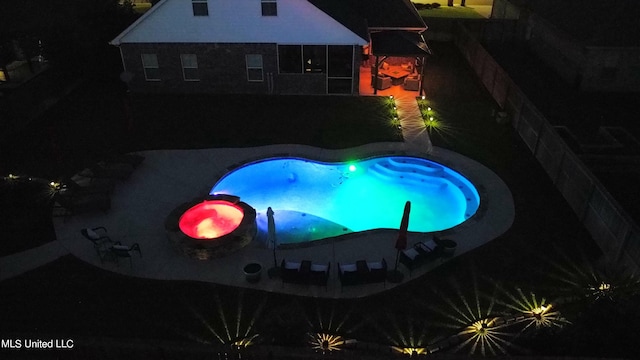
0,0,136,76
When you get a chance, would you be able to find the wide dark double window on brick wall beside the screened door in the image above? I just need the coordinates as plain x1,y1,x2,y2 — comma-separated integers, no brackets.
278,45,327,74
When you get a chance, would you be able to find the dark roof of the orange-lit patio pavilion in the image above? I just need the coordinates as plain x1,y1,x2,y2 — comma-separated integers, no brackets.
371,31,431,56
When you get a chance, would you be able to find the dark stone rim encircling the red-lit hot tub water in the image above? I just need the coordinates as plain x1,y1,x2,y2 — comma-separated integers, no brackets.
164,195,258,260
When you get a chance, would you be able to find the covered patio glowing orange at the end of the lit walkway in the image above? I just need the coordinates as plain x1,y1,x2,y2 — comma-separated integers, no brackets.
359,31,431,96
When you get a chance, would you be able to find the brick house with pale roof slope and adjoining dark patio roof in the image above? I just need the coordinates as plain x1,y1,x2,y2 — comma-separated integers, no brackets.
111,0,428,94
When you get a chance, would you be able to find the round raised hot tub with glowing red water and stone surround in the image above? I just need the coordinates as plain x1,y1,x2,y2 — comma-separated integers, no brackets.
165,195,257,260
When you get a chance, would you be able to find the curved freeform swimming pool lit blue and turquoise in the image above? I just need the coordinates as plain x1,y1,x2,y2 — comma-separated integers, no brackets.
210,156,480,243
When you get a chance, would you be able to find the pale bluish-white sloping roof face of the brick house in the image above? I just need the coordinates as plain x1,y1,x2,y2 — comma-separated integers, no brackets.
110,0,368,45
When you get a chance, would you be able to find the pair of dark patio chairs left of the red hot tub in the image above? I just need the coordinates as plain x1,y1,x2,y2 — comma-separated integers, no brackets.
80,226,142,267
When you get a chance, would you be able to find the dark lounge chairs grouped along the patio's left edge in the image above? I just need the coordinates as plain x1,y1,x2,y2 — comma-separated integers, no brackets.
53,154,144,219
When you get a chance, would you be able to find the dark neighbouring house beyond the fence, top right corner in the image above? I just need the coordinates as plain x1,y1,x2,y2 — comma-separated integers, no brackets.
492,0,640,92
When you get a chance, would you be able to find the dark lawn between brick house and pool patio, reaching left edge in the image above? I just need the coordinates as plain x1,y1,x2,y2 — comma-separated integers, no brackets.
0,80,401,179
